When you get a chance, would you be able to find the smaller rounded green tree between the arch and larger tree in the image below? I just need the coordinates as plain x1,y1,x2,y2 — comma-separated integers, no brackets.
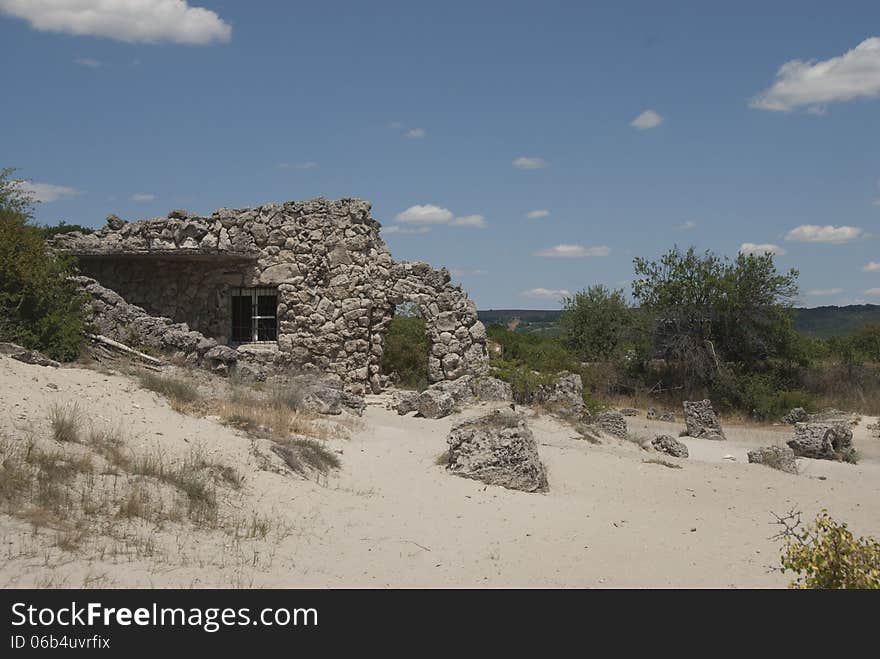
559,284,645,361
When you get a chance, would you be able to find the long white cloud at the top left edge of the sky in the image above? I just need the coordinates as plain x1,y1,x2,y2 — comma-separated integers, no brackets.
0,0,232,45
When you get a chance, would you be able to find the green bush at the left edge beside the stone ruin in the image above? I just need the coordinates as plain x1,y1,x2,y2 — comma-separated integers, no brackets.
0,169,84,361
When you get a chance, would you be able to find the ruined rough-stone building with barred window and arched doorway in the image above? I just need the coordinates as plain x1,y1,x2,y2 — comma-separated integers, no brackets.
52,198,488,393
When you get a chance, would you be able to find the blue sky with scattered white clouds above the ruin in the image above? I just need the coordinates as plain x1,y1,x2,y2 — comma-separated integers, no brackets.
0,0,880,309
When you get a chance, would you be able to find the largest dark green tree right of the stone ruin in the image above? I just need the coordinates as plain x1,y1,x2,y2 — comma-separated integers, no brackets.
633,247,798,381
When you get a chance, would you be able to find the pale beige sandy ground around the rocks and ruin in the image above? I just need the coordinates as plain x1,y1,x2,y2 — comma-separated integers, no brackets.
0,358,880,587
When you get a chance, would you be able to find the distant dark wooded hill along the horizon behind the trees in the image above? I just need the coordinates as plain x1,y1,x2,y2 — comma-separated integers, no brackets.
478,304,880,339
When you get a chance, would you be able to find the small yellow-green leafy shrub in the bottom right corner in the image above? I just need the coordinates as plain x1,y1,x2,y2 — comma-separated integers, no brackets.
773,510,880,589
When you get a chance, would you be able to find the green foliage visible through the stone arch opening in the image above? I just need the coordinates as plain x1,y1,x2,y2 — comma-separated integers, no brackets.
382,304,429,389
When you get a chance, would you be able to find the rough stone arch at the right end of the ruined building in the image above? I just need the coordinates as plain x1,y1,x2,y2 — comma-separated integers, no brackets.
371,262,489,389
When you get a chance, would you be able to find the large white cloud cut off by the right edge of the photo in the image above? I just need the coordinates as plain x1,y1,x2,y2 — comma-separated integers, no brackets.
750,37,880,113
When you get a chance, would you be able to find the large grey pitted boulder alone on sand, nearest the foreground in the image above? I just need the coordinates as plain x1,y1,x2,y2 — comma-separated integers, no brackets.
446,409,548,492
